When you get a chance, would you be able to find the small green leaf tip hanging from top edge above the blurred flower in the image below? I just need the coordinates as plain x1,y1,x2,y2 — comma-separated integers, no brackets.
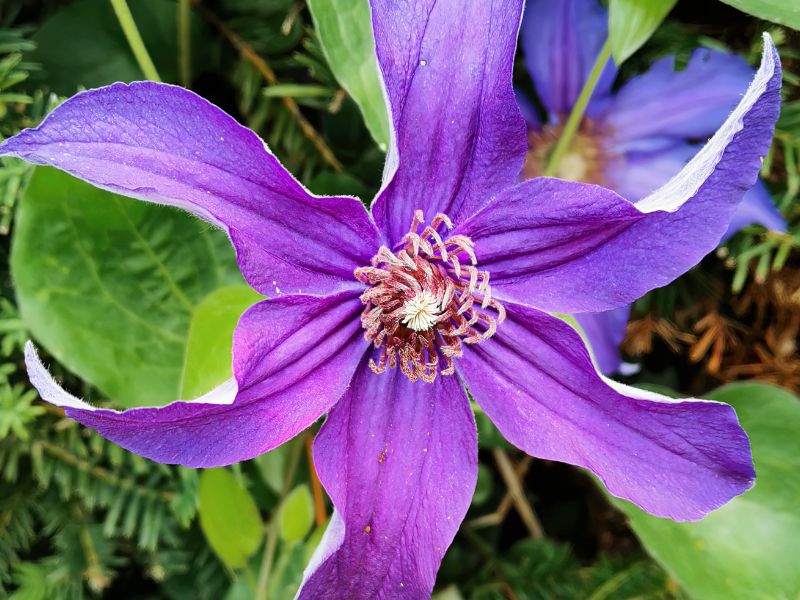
608,0,677,65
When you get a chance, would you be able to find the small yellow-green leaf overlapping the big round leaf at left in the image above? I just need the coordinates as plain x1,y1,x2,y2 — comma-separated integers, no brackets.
180,283,263,398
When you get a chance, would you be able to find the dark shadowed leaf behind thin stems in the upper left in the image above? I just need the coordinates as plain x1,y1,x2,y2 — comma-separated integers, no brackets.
31,0,214,96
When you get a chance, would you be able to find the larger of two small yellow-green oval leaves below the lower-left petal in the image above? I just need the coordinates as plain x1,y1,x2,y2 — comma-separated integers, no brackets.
199,469,264,569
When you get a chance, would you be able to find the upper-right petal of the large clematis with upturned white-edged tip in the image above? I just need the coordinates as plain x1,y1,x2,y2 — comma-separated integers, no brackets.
457,38,781,313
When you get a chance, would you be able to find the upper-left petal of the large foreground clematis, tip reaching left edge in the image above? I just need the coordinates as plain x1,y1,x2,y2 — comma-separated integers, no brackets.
0,82,380,296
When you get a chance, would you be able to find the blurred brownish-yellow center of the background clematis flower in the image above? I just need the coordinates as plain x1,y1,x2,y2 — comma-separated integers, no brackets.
522,119,614,185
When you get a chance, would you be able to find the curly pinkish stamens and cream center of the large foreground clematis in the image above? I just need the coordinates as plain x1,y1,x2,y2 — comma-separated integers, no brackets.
355,210,505,383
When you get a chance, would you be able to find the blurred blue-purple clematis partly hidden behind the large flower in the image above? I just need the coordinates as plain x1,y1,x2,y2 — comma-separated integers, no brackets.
518,0,786,373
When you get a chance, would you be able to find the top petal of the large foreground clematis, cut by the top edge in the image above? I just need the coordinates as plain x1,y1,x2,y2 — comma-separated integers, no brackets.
372,0,526,244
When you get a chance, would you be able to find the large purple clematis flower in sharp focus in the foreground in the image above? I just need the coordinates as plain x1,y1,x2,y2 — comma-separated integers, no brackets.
0,0,781,599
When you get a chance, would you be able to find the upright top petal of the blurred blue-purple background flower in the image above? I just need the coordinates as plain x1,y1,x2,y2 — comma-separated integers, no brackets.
520,0,617,121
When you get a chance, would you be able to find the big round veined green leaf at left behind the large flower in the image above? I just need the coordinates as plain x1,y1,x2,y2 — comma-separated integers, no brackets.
11,167,242,406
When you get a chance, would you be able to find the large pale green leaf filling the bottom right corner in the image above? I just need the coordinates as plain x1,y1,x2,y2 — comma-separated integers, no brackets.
615,383,800,600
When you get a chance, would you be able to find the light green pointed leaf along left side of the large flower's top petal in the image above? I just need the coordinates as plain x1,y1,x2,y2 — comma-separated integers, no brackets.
308,0,389,151
